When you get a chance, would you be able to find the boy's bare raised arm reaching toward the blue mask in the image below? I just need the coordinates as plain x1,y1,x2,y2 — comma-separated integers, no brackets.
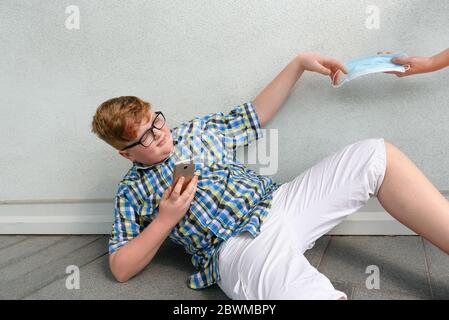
253,53,347,126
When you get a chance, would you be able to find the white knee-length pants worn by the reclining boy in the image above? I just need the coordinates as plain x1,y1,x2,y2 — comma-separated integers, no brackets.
218,138,386,300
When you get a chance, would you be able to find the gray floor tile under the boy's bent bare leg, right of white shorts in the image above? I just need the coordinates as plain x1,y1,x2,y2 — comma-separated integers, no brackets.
319,236,431,298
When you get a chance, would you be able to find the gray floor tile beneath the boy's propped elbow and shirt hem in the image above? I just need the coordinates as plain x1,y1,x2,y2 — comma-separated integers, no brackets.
27,241,228,300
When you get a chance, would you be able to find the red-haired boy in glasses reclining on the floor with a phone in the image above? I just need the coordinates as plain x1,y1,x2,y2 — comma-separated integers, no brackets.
92,53,449,299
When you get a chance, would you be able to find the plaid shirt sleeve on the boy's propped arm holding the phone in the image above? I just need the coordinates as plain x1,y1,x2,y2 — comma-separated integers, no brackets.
109,193,140,254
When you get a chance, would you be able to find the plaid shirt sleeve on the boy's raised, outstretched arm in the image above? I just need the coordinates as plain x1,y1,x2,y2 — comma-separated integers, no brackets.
202,102,263,147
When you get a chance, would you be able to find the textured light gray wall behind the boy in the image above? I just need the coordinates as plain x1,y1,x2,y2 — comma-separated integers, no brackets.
0,0,449,200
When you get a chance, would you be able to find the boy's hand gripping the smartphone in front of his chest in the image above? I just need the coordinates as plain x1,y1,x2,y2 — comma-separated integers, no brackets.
157,175,198,227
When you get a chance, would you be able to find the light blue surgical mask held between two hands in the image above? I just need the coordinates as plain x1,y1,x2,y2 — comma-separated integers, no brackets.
332,53,410,88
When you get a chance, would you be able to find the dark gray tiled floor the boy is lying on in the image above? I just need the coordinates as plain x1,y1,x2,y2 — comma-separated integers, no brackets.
0,235,449,300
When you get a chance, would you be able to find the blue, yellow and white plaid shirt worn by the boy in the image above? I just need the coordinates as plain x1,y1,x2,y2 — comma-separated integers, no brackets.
109,102,281,289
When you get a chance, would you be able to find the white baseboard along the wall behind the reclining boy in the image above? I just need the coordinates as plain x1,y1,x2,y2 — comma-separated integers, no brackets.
0,198,415,235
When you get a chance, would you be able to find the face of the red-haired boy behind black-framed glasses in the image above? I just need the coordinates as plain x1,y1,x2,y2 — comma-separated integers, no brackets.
119,112,173,165
